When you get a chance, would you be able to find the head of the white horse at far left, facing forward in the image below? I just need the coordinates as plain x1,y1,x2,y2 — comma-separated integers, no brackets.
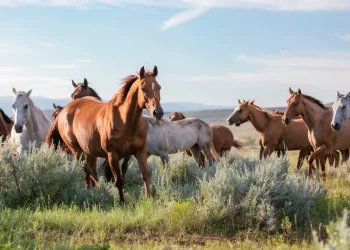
12,88,32,133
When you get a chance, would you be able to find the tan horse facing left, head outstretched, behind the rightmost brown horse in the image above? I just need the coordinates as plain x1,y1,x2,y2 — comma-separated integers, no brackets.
226,100,312,169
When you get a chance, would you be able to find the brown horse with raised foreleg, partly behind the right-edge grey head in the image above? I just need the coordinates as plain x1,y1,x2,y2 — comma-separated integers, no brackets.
282,88,350,180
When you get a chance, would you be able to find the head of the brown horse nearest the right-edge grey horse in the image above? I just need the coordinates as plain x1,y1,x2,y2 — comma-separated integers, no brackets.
282,88,303,125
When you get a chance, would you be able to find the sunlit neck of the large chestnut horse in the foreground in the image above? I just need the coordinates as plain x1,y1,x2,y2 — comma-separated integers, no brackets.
112,83,142,130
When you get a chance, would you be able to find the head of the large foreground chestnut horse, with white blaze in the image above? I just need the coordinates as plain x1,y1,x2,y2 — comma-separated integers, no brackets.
138,66,164,120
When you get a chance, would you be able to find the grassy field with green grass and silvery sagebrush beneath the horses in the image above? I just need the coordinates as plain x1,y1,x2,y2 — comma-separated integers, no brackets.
0,110,350,249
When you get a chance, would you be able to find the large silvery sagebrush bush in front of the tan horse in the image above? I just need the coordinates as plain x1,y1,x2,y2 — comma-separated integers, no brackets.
199,156,326,230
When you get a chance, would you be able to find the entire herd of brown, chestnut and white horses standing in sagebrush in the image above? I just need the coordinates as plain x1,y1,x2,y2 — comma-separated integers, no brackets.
0,66,350,203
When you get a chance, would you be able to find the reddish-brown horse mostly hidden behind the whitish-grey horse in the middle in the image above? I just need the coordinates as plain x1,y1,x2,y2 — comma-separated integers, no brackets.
168,112,243,165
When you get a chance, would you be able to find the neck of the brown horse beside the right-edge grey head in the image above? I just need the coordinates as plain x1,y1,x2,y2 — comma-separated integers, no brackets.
301,98,329,131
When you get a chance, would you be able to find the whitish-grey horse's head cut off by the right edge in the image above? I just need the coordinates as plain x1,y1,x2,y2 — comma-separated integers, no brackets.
331,92,350,131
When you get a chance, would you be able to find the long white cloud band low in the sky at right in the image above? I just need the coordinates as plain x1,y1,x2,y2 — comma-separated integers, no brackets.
179,52,350,88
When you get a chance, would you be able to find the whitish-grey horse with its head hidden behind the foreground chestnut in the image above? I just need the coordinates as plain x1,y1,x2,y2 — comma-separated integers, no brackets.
145,117,217,164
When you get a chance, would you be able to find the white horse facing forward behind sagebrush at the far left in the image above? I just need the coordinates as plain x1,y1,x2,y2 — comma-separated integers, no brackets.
10,88,52,155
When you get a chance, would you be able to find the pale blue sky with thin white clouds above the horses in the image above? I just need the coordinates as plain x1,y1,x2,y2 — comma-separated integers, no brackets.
0,0,350,107
